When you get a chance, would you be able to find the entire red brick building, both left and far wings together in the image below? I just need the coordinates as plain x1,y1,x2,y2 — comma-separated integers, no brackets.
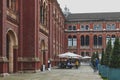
0,0,120,76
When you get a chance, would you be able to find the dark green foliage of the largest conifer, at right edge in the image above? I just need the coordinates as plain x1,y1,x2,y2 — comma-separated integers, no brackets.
110,38,120,68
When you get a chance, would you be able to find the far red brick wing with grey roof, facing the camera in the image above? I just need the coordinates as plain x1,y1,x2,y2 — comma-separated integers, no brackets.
65,12,120,56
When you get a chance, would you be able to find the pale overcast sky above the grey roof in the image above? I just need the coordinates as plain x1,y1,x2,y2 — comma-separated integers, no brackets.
57,0,120,13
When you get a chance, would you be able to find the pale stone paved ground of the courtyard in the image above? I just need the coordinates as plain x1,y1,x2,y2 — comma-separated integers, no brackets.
0,65,102,80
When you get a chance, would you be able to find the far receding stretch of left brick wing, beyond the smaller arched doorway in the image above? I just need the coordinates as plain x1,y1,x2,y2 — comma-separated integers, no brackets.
49,0,65,65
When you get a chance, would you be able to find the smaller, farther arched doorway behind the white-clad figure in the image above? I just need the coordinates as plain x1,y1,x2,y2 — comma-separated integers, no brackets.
41,40,46,65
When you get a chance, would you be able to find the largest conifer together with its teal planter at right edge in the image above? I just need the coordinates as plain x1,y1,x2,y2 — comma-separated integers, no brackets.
108,38,120,80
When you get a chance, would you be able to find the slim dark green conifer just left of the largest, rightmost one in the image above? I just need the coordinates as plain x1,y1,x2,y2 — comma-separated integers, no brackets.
104,39,112,66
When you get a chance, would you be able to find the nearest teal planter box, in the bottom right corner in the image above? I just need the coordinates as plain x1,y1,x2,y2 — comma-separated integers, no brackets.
108,68,120,80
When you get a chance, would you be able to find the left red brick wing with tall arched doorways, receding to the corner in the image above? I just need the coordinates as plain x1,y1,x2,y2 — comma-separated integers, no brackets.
0,0,65,76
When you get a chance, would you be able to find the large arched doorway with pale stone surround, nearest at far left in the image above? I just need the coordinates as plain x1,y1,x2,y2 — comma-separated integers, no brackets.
6,30,18,73
